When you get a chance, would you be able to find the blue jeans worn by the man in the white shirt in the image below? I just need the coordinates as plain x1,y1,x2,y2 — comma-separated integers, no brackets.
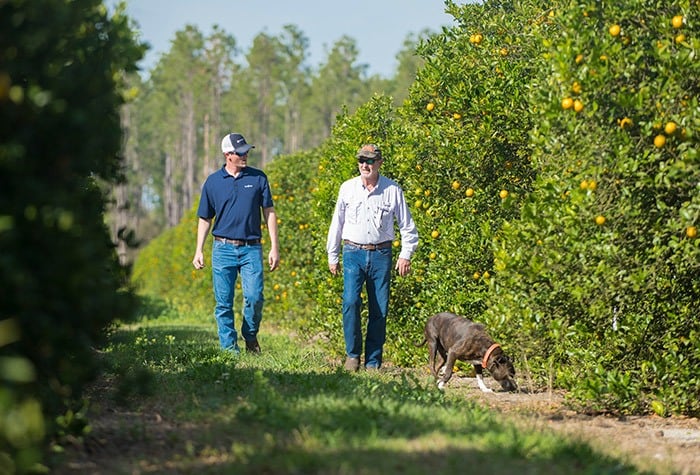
343,244,391,368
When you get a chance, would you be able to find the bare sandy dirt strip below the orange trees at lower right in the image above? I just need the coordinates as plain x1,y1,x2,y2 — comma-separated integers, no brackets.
448,375,700,475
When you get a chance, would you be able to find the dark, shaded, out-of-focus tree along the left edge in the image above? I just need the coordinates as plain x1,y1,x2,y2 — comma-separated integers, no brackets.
0,0,144,473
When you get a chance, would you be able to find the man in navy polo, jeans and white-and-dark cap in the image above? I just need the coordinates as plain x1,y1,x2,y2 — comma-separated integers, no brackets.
192,133,280,353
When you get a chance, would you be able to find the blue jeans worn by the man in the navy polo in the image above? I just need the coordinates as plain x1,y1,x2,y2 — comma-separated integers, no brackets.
211,240,264,352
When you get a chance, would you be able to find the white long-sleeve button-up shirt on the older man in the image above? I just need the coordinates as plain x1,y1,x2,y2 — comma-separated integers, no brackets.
326,175,418,264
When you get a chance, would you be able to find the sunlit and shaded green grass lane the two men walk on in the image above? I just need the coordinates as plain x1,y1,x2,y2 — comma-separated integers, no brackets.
50,320,652,475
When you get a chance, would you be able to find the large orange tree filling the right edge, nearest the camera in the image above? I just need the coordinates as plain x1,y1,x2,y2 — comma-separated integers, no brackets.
487,0,700,414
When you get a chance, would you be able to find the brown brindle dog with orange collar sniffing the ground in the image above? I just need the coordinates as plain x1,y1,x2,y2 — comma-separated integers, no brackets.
416,312,517,393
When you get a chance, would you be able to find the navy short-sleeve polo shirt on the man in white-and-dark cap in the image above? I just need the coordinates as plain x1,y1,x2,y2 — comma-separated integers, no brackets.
197,166,273,240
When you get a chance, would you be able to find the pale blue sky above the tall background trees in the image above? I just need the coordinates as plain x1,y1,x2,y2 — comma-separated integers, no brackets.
110,0,464,77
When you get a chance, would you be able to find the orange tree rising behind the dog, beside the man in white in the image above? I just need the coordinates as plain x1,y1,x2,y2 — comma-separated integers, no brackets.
389,2,548,363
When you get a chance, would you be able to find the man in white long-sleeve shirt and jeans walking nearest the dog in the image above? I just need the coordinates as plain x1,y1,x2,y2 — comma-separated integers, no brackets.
326,144,418,371
